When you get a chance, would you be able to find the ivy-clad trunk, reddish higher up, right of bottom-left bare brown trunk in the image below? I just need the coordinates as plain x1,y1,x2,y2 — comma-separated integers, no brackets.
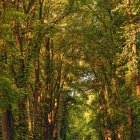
13,17,28,140
